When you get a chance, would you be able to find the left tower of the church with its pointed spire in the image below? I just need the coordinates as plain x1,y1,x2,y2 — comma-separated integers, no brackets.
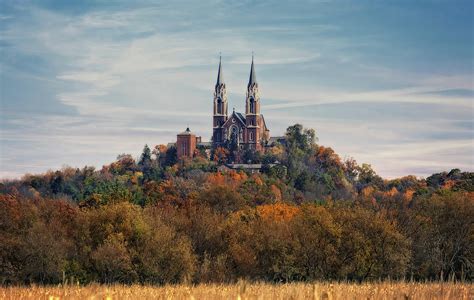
212,57,228,147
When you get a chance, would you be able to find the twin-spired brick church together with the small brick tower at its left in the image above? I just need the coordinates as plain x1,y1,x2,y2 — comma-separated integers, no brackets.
175,55,272,158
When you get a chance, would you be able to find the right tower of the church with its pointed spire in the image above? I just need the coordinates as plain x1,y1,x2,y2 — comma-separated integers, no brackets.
245,55,262,150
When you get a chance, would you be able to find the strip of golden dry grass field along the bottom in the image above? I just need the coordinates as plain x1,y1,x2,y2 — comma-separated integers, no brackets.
0,283,474,300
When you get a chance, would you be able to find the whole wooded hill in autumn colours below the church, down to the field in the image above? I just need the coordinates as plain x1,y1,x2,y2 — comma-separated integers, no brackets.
0,124,474,283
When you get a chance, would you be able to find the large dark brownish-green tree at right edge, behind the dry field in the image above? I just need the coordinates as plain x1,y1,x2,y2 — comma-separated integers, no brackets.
408,192,474,280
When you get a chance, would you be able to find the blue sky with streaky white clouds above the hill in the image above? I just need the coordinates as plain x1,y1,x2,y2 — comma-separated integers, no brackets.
0,0,474,178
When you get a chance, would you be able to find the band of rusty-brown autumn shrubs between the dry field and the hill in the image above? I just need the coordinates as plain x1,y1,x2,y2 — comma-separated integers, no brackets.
0,191,474,284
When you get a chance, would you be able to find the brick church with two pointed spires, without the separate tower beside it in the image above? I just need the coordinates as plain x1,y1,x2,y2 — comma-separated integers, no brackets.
212,57,270,151
